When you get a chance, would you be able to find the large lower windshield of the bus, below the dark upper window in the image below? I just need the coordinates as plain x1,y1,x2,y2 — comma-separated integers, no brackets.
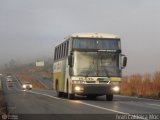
73,51,121,77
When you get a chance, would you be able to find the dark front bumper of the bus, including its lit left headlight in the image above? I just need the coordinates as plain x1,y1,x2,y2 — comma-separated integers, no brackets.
72,84,113,95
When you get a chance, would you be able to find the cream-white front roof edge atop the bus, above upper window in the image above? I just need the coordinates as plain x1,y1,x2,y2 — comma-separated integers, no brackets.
68,33,120,39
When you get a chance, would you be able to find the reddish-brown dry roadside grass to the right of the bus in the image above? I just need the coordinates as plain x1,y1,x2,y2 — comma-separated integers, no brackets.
120,72,160,99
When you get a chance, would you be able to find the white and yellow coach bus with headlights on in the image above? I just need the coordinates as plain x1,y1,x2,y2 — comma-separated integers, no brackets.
53,33,127,101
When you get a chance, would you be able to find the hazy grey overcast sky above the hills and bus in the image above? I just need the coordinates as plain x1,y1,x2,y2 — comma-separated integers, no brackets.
0,0,160,74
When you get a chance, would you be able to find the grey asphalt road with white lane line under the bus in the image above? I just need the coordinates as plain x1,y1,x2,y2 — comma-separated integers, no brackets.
2,77,160,120
